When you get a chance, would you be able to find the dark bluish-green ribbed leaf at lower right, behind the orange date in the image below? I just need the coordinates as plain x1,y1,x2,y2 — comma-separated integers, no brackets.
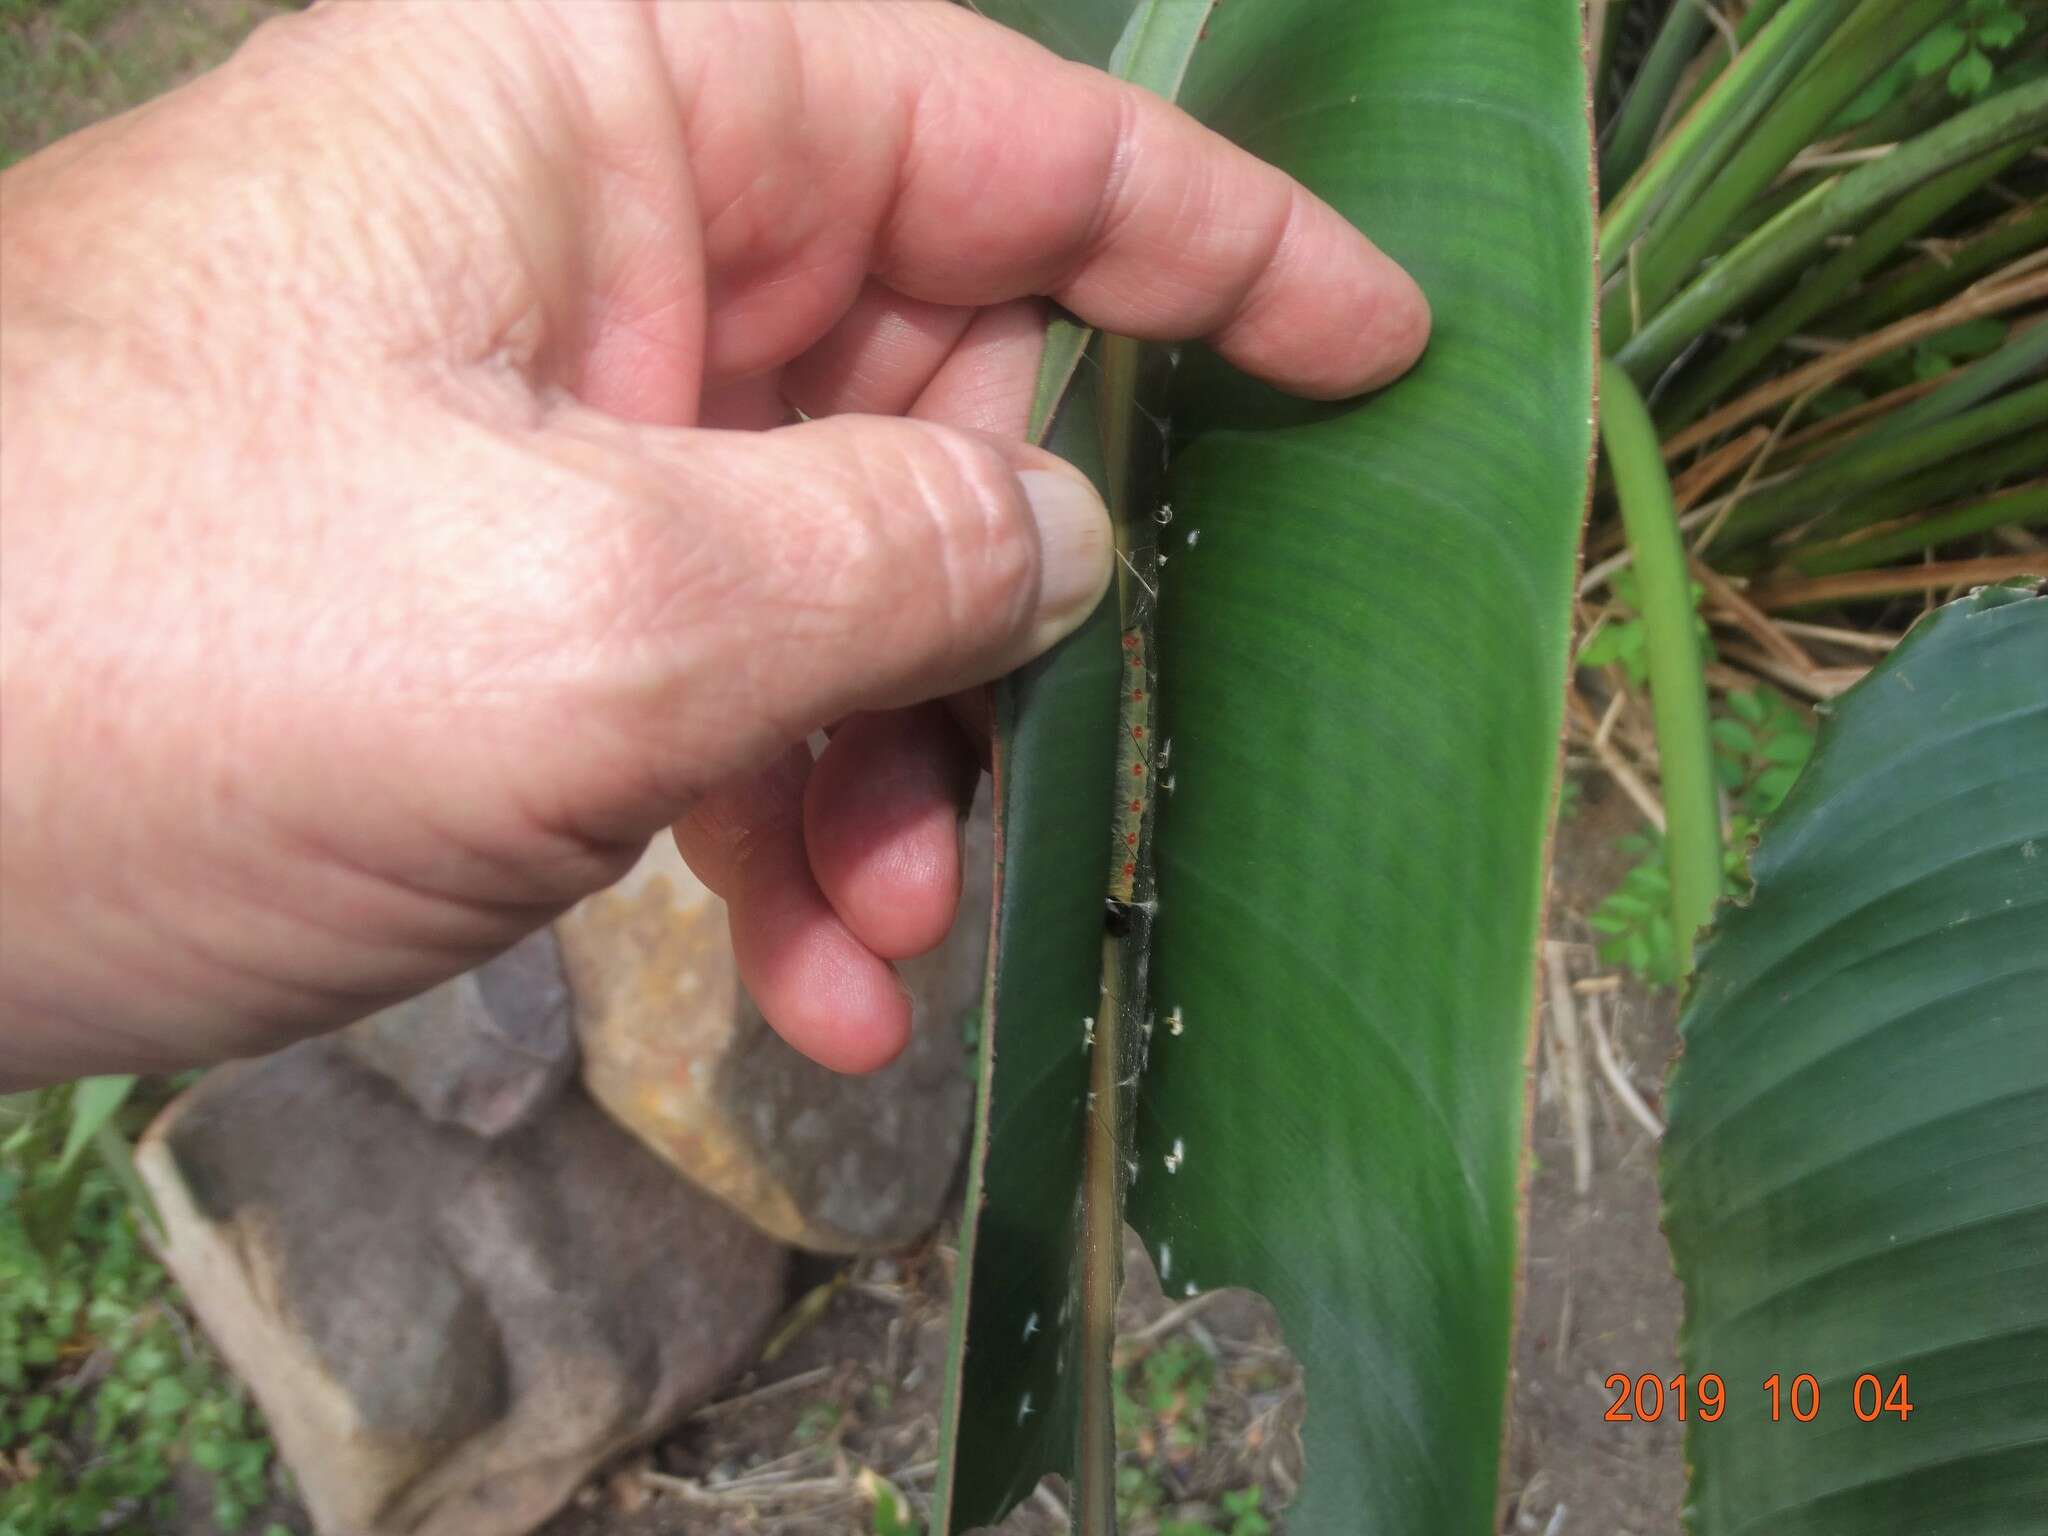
1663,588,2048,1536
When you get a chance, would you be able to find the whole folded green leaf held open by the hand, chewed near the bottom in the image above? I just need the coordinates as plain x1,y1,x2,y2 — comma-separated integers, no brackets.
934,0,1593,1536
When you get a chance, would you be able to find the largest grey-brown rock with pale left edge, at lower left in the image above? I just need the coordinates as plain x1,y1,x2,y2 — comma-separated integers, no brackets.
137,1040,786,1536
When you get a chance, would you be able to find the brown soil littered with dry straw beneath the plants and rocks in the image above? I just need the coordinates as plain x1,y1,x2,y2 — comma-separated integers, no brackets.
0,0,1683,1536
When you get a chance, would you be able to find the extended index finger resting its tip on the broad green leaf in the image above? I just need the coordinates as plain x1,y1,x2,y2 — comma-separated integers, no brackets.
666,4,1430,399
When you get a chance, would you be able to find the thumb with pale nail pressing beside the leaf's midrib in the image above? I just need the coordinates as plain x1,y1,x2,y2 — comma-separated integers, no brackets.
552,416,1114,786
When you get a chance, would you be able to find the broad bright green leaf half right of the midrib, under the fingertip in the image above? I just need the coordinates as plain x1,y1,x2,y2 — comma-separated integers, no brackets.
1130,0,1593,1536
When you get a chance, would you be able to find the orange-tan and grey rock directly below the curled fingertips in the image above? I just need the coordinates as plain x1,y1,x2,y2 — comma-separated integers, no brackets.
557,793,993,1253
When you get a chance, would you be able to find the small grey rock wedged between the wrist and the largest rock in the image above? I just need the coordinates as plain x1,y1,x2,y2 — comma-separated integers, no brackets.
342,928,575,1137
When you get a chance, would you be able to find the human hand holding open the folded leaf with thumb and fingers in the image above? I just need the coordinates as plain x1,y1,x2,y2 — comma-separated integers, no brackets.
0,0,1427,1083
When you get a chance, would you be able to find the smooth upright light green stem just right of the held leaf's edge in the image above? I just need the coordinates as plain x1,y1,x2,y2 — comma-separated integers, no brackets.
1599,362,1720,971
